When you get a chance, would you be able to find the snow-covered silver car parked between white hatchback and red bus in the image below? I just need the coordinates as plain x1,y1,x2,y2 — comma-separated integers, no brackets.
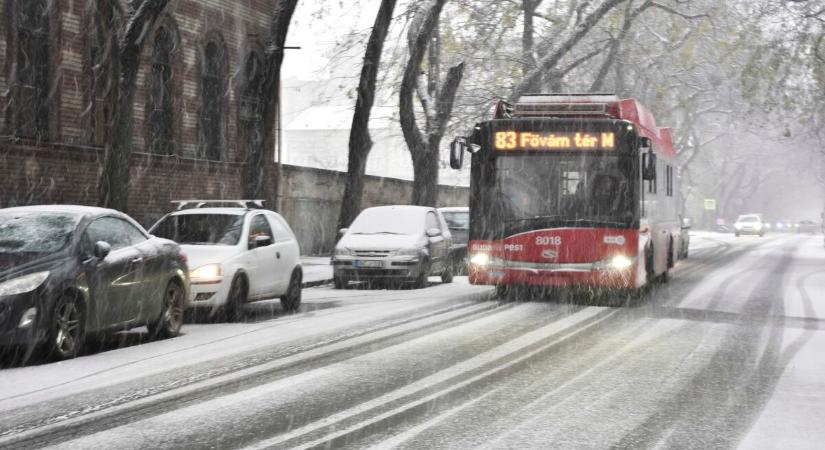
332,206,453,289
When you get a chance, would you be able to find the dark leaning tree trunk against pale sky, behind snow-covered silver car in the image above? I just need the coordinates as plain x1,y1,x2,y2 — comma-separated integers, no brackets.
338,0,396,228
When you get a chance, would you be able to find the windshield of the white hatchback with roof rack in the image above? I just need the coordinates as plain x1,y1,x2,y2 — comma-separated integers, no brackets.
150,214,244,245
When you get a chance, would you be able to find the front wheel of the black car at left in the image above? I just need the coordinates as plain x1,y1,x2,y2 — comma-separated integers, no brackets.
46,295,86,360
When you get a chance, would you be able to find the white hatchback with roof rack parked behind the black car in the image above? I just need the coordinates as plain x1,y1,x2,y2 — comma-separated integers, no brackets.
150,200,303,321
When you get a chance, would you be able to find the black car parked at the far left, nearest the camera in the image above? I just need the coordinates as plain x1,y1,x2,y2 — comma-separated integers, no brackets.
0,206,189,359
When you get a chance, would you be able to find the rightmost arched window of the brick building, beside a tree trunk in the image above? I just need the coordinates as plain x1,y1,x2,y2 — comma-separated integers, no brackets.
239,51,264,162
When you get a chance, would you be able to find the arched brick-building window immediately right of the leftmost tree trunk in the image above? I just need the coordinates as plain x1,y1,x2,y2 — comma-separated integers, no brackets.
146,26,175,155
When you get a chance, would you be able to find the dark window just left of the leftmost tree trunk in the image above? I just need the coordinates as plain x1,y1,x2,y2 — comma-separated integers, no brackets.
82,1,115,146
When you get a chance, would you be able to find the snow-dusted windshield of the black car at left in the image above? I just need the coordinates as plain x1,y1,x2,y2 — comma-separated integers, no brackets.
0,212,80,255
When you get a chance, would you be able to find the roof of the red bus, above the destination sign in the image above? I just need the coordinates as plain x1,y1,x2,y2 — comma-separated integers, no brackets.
493,94,676,158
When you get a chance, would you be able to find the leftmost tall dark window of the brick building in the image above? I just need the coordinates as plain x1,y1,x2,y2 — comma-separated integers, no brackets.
13,0,49,139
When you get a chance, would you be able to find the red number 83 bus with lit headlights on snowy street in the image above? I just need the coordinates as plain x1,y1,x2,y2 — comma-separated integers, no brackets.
450,94,682,289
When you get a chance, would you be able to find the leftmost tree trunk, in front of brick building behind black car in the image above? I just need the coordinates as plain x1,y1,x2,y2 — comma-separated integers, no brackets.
98,0,169,211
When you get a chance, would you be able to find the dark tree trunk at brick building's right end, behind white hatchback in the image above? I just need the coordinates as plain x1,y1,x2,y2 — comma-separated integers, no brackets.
244,0,298,201
